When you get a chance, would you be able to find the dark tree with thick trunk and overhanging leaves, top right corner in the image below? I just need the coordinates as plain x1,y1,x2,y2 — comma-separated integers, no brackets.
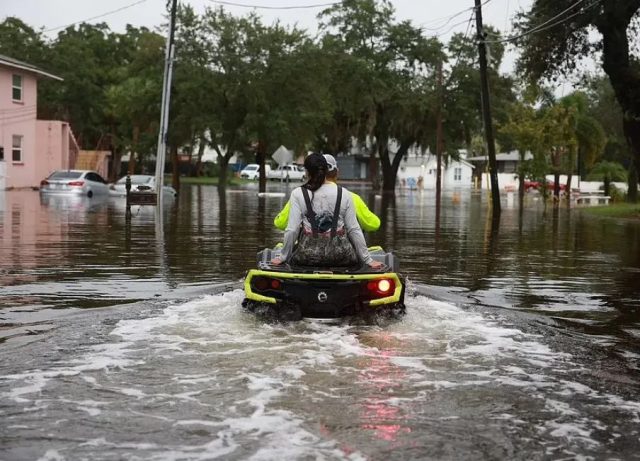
516,0,640,200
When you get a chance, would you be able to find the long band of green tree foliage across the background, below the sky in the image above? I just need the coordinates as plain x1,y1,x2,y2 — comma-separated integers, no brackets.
0,0,514,189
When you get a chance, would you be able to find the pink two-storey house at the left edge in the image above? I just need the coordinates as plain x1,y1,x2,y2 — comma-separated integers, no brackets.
0,55,79,190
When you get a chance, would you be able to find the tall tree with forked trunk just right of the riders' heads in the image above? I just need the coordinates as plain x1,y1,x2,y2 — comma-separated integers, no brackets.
320,0,444,193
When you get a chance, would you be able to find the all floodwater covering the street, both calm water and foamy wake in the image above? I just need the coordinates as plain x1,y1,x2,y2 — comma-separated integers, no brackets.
0,185,640,461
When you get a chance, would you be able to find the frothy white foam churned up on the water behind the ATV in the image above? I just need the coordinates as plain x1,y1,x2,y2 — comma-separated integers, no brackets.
0,290,640,461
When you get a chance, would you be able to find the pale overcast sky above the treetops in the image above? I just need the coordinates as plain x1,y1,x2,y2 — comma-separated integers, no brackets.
0,0,532,71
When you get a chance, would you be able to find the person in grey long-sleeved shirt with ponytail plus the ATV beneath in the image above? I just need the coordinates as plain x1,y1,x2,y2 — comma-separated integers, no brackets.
242,154,405,320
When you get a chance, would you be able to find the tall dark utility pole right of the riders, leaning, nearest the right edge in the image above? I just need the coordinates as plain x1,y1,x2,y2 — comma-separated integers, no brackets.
475,0,501,217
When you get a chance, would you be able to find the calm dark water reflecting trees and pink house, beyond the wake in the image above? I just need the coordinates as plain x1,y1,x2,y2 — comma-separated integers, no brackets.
0,184,640,344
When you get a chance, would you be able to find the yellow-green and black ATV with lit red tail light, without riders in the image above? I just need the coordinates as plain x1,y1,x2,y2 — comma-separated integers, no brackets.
242,247,405,320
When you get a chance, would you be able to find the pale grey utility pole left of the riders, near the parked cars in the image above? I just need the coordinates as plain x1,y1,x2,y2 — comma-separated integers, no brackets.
156,0,178,208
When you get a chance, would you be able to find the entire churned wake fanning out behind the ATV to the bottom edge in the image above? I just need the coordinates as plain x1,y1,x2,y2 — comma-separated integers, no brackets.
0,290,640,460
